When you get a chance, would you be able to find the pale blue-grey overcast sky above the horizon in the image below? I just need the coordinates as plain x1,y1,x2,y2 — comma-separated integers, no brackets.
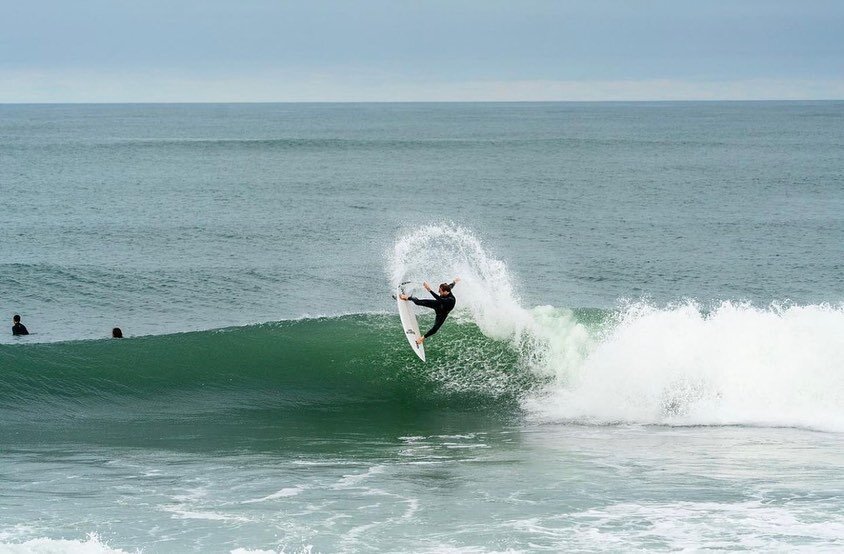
0,0,844,102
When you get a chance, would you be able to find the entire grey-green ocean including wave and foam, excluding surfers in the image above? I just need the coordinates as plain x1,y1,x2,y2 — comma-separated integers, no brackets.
0,102,844,553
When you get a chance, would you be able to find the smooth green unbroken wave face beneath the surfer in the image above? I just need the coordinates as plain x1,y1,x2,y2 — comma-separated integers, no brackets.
0,315,536,430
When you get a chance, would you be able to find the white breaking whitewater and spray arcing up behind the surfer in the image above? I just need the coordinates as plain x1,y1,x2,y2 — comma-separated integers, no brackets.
390,225,844,431
